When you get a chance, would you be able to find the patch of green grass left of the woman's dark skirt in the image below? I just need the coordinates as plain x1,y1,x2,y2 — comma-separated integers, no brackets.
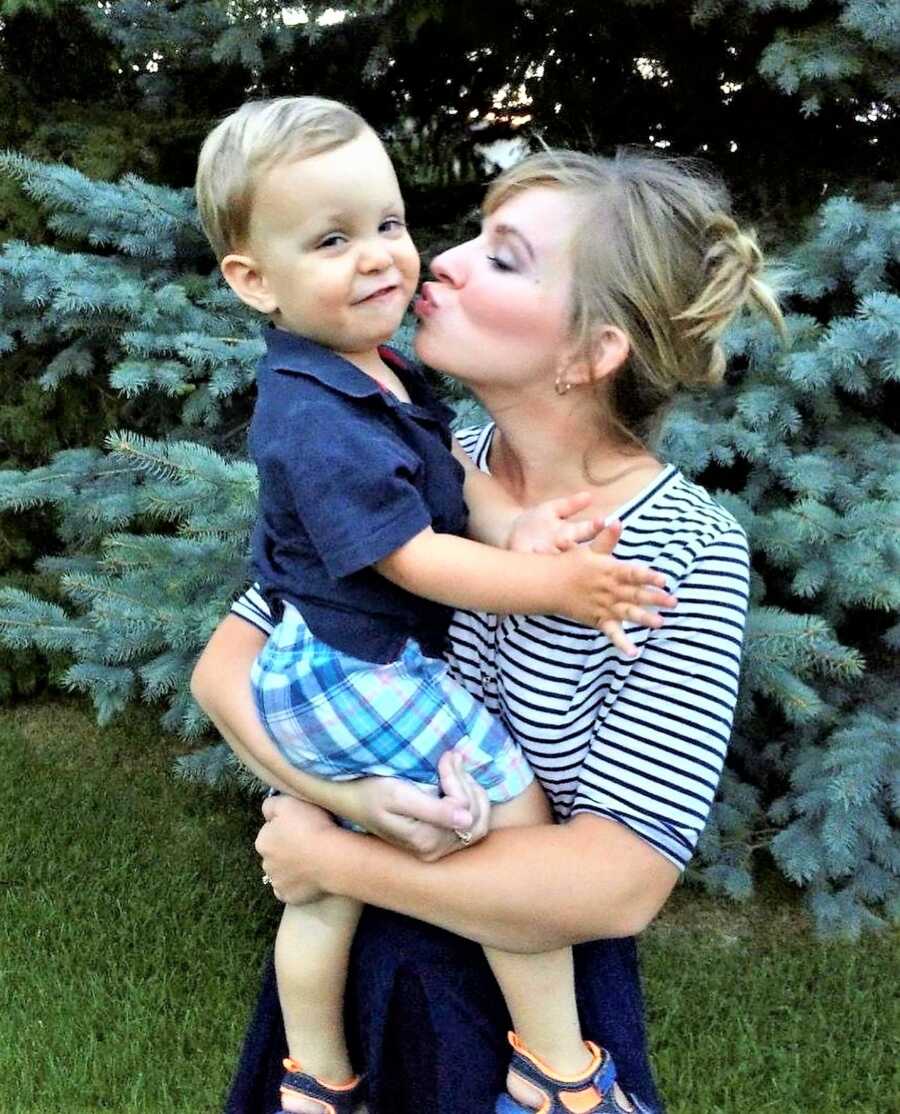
0,702,275,1114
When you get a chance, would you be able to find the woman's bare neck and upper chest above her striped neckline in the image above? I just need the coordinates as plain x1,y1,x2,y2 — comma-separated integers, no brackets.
482,387,663,517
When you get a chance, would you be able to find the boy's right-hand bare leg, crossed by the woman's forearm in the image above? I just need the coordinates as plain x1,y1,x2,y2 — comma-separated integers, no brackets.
485,783,629,1111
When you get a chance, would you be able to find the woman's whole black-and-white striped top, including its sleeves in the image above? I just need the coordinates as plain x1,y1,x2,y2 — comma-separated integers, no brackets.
233,426,750,868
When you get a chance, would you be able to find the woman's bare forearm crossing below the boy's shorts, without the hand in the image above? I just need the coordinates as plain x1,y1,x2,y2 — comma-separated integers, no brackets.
311,815,678,951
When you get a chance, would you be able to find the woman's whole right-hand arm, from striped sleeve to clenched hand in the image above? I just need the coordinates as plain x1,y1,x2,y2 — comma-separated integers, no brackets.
256,529,749,951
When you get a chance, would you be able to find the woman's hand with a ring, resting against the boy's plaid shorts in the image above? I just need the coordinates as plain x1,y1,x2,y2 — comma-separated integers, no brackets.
353,751,490,862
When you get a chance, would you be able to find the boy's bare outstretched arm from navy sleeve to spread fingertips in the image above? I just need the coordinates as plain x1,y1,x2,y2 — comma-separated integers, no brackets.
375,527,677,655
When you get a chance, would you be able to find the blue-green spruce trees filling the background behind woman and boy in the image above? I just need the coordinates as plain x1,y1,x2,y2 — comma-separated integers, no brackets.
0,0,900,934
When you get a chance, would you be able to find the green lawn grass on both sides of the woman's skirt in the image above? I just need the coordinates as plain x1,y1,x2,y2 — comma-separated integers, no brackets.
0,700,900,1114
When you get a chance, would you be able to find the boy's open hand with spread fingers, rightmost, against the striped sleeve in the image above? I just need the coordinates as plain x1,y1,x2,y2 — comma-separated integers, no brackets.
559,522,678,657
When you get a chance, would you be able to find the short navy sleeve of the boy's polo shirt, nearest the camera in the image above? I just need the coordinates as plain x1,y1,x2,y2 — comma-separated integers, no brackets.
265,407,432,577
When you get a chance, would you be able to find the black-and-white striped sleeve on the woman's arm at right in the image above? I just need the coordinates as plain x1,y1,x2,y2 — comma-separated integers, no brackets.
571,527,750,870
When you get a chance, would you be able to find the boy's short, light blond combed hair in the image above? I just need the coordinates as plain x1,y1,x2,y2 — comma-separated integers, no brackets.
196,97,369,260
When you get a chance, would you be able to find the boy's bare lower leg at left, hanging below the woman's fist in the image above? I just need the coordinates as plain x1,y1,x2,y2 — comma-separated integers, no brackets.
275,897,362,1114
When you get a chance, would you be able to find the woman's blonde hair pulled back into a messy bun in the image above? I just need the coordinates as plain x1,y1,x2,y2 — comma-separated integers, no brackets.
485,149,784,447
